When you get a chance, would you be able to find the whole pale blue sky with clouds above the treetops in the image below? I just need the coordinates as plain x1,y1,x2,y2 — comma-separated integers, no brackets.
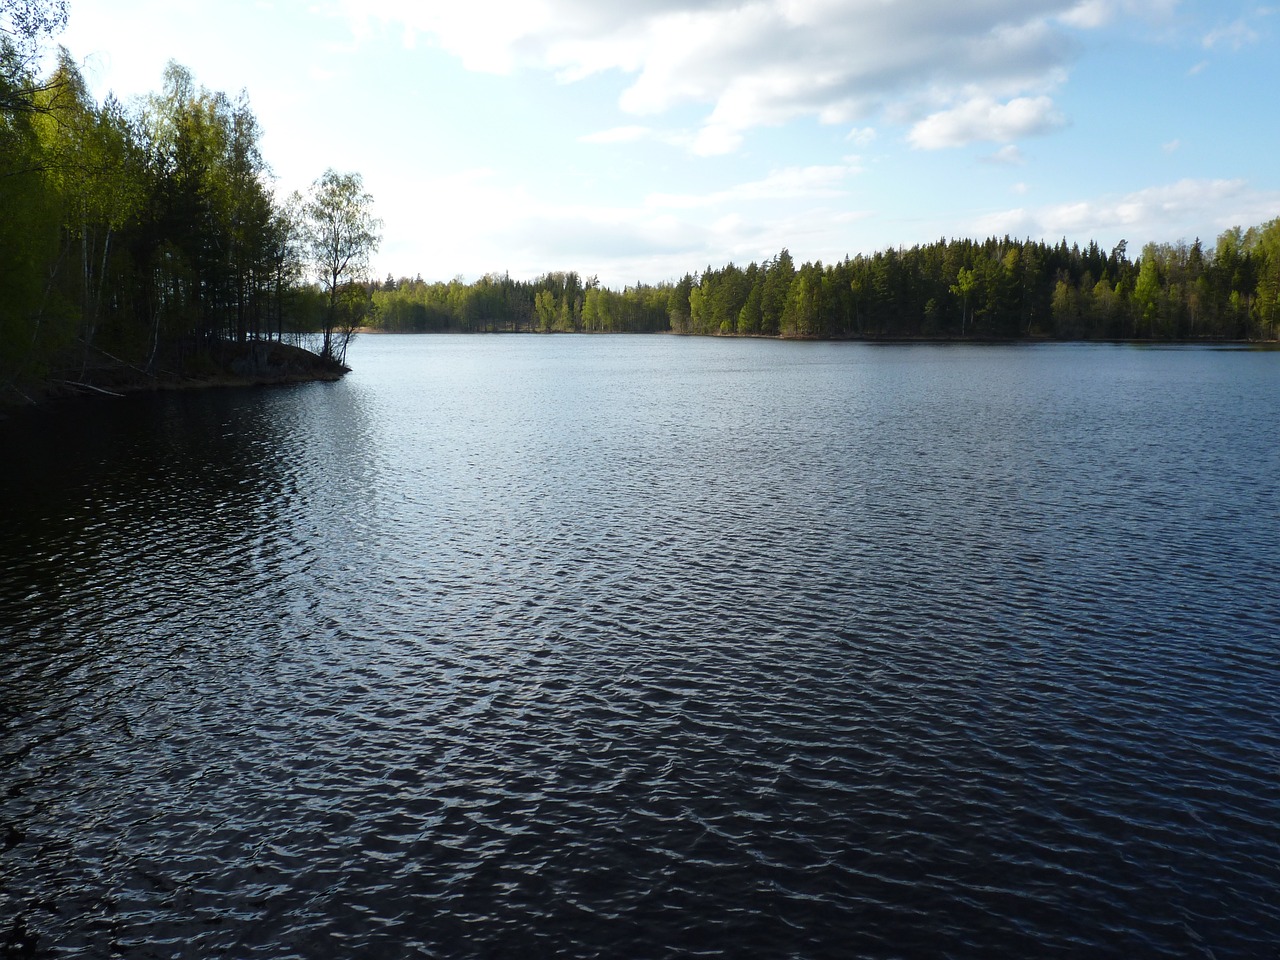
45,0,1280,288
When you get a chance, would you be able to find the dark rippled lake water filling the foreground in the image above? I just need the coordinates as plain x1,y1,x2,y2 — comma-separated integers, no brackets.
0,337,1280,960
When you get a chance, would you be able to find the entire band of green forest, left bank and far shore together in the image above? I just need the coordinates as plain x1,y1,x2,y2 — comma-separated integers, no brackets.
0,0,1280,394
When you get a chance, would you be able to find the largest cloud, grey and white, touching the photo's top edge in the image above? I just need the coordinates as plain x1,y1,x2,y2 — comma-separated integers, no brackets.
340,0,1141,155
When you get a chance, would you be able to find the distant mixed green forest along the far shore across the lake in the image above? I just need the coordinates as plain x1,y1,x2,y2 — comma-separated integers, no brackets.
372,225,1280,340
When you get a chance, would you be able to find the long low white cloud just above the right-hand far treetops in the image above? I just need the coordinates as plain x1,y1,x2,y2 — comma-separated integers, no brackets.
974,179,1280,243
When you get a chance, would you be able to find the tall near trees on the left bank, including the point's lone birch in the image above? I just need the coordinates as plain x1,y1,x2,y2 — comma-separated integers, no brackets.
0,0,378,399
